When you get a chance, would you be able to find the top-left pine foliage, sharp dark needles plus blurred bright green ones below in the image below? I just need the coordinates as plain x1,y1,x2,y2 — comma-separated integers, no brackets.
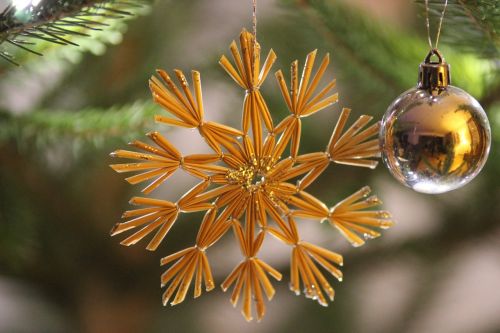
0,0,148,65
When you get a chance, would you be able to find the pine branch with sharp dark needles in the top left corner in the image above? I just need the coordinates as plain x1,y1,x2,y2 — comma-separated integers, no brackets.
0,0,144,65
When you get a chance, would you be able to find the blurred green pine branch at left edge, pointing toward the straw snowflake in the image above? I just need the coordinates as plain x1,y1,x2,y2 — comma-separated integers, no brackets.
0,102,157,146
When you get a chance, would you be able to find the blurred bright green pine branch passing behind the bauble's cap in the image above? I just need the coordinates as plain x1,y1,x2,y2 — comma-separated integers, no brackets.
286,0,493,109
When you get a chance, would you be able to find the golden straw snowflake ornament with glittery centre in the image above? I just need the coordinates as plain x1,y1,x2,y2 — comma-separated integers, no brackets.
111,30,392,320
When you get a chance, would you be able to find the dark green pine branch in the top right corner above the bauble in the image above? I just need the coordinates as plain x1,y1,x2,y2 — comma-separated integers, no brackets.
418,0,500,59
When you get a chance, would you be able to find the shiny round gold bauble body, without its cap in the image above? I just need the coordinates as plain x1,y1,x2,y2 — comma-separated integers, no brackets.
380,86,491,193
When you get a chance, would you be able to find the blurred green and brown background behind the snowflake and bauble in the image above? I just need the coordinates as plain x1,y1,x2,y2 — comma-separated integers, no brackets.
0,0,500,333
